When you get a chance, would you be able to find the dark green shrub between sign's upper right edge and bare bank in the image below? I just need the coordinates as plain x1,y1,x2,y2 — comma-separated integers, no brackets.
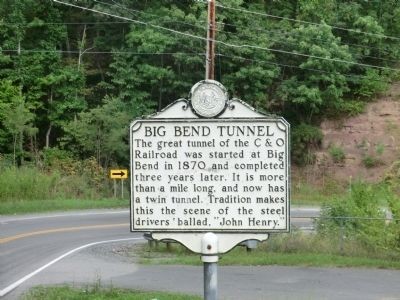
291,123,323,165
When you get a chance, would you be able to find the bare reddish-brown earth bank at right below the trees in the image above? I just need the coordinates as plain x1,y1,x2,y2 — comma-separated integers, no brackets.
301,83,400,184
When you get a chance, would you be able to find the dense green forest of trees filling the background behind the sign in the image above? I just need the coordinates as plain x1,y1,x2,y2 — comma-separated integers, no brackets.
0,0,400,167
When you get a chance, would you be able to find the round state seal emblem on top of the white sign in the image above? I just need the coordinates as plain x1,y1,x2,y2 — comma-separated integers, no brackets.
190,80,228,118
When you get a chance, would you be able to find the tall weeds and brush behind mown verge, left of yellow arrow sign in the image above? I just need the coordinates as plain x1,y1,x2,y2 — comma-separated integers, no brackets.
0,155,111,202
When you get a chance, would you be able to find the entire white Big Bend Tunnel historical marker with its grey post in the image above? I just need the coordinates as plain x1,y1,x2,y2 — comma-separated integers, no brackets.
130,80,290,299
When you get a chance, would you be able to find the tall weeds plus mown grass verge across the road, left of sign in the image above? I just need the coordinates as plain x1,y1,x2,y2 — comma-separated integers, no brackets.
0,166,129,215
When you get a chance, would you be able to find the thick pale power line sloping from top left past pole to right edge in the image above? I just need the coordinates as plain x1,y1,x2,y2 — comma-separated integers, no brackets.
53,0,400,71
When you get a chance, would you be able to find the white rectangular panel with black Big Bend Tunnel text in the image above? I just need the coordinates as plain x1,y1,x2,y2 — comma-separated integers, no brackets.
130,118,289,233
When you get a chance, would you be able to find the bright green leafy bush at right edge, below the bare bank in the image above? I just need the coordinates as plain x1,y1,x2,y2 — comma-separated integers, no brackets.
317,182,400,251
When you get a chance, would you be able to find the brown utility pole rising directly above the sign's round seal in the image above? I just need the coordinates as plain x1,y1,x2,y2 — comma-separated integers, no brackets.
206,0,216,79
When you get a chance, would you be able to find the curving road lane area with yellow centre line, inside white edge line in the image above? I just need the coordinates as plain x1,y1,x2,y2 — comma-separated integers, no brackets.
0,210,139,296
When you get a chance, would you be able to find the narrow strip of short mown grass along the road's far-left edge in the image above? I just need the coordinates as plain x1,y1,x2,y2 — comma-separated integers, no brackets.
0,198,129,215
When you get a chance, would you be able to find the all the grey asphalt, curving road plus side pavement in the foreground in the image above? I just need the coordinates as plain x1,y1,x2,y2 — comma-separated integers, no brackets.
0,208,400,300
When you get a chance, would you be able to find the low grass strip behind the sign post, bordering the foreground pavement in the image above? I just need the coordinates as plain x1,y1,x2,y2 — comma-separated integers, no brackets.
132,233,400,269
